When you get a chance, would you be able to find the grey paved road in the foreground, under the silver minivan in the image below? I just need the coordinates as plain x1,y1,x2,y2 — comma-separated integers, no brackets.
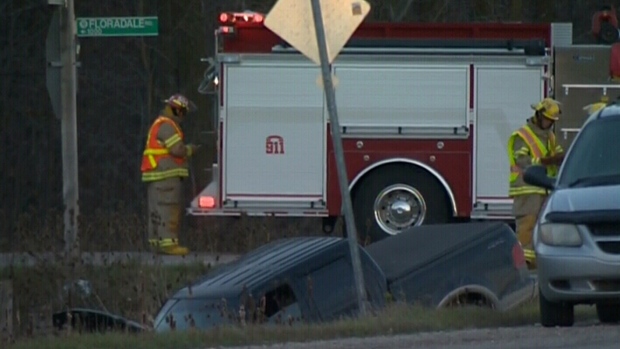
232,324,620,349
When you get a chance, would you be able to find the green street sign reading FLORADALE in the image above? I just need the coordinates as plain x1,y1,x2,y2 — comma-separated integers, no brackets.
76,16,159,37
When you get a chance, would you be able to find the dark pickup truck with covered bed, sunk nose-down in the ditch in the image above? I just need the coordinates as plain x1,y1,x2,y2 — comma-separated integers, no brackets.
149,222,535,332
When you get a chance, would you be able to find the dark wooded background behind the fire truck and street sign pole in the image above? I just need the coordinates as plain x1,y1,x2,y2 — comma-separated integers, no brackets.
0,0,618,251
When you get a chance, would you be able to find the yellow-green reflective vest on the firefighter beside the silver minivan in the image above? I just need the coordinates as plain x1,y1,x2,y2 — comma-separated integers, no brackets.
508,125,558,197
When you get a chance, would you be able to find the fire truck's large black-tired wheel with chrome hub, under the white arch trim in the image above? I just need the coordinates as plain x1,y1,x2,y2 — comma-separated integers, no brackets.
352,164,451,244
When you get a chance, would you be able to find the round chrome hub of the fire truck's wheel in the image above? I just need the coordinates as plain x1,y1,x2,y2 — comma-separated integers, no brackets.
374,184,426,235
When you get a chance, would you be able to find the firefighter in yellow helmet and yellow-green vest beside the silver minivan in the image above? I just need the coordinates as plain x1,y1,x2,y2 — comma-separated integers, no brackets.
508,98,564,269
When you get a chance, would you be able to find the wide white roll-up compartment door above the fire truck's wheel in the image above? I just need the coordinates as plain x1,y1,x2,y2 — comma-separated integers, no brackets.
335,63,470,134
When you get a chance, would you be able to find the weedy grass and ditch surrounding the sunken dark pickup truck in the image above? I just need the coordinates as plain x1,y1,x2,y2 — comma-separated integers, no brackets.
0,211,595,349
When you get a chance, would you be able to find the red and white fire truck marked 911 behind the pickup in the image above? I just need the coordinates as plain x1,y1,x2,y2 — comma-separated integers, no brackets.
188,8,620,241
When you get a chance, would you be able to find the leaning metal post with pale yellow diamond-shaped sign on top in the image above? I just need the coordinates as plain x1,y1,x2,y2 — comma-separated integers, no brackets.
265,0,370,315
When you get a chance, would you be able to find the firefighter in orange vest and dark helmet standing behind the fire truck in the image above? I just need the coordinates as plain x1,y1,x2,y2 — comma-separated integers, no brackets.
141,94,198,255
